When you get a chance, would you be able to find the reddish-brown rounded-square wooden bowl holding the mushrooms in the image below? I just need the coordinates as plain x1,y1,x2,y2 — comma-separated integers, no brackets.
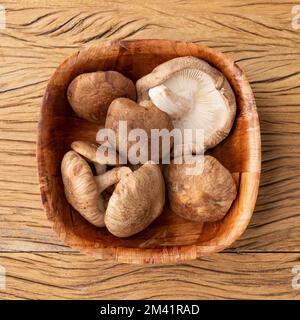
37,40,261,263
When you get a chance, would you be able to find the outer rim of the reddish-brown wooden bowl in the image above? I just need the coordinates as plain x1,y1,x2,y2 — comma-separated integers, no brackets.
36,39,261,264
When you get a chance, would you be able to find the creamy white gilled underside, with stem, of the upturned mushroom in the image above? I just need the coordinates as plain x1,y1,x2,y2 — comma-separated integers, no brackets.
149,68,227,148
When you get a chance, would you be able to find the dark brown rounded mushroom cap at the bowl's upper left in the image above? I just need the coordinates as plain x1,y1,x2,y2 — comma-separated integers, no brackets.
67,71,136,123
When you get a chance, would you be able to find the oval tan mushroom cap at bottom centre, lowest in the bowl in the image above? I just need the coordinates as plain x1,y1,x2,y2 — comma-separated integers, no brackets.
105,161,165,237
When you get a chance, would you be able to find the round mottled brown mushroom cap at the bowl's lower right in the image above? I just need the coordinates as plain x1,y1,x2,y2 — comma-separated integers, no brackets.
164,156,237,222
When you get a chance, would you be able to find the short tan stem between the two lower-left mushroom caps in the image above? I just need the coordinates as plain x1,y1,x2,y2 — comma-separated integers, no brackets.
94,167,132,194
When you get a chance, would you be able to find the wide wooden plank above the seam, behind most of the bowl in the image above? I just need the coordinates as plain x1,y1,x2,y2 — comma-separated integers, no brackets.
0,0,300,252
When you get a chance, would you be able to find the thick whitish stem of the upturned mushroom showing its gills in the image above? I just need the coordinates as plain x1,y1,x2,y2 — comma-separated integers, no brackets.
149,84,191,119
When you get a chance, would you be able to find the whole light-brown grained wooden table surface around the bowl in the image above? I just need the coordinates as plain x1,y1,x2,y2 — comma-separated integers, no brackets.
0,0,300,299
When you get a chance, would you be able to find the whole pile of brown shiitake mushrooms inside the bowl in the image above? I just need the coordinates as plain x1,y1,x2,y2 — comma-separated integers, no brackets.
61,57,237,237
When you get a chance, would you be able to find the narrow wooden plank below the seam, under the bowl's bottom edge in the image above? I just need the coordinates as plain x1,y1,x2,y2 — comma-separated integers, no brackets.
0,253,300,300
